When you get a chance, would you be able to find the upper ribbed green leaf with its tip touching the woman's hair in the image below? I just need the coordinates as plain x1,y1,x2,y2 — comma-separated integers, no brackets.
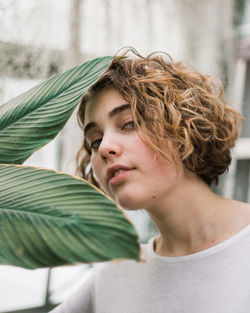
0,57,112,164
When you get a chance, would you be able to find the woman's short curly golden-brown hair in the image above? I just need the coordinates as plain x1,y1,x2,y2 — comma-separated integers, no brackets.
77,49,242,186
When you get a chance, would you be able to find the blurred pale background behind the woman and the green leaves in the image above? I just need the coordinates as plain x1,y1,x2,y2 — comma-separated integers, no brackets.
0,0,250,313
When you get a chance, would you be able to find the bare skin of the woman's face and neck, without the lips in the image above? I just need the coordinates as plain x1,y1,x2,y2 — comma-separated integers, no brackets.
85,89,250,256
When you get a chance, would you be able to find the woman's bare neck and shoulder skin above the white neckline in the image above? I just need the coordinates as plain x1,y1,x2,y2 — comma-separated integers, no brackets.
148,176,250,256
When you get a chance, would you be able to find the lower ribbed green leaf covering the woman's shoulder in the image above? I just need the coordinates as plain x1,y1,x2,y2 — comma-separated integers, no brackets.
0,165,140,269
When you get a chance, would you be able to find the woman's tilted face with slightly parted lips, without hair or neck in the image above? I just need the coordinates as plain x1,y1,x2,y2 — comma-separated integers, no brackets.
85,89,186,210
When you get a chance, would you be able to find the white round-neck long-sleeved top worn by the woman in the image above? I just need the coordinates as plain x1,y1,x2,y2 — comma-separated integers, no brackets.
51,225,250,313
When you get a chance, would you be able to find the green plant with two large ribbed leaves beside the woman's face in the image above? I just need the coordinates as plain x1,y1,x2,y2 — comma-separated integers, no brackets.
0,57,140,269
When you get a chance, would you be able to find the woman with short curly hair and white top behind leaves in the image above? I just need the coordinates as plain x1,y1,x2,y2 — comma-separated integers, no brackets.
50,47,250,313
